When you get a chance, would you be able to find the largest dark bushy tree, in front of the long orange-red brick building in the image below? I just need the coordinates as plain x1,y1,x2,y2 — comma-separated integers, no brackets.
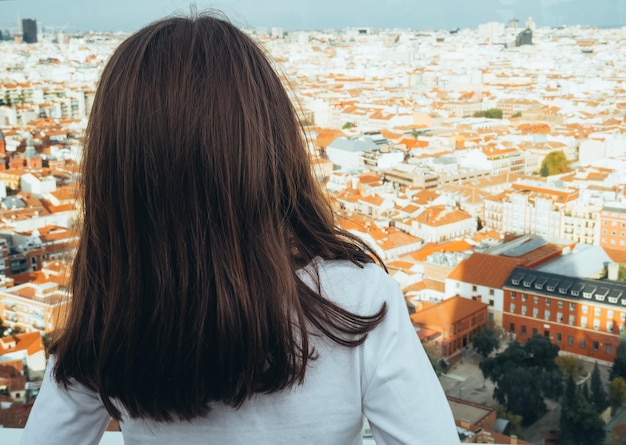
479,336,563,425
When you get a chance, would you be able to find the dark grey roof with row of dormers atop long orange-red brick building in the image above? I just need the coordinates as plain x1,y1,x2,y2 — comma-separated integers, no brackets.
503,267,626,309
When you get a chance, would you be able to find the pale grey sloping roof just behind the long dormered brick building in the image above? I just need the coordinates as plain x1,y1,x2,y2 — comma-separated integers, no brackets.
536,244,612,278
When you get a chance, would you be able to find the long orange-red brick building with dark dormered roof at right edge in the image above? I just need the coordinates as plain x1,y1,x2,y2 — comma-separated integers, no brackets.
502,268,626,361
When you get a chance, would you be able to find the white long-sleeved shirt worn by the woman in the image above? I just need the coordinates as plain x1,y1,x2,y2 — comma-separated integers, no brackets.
21,259,459,445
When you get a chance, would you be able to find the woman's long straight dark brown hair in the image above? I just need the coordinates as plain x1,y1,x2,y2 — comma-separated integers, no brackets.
51,15,386,421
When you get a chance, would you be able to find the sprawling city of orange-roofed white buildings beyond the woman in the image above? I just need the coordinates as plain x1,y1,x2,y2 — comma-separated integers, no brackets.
0,3,626,444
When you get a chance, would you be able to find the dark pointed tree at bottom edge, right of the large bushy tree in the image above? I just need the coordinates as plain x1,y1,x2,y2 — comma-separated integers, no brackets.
559,375,605,445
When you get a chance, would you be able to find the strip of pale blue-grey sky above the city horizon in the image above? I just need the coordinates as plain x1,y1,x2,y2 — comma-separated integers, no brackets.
0,0,626,32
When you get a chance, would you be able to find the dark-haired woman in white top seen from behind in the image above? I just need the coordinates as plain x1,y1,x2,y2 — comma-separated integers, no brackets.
23,16,458,445
